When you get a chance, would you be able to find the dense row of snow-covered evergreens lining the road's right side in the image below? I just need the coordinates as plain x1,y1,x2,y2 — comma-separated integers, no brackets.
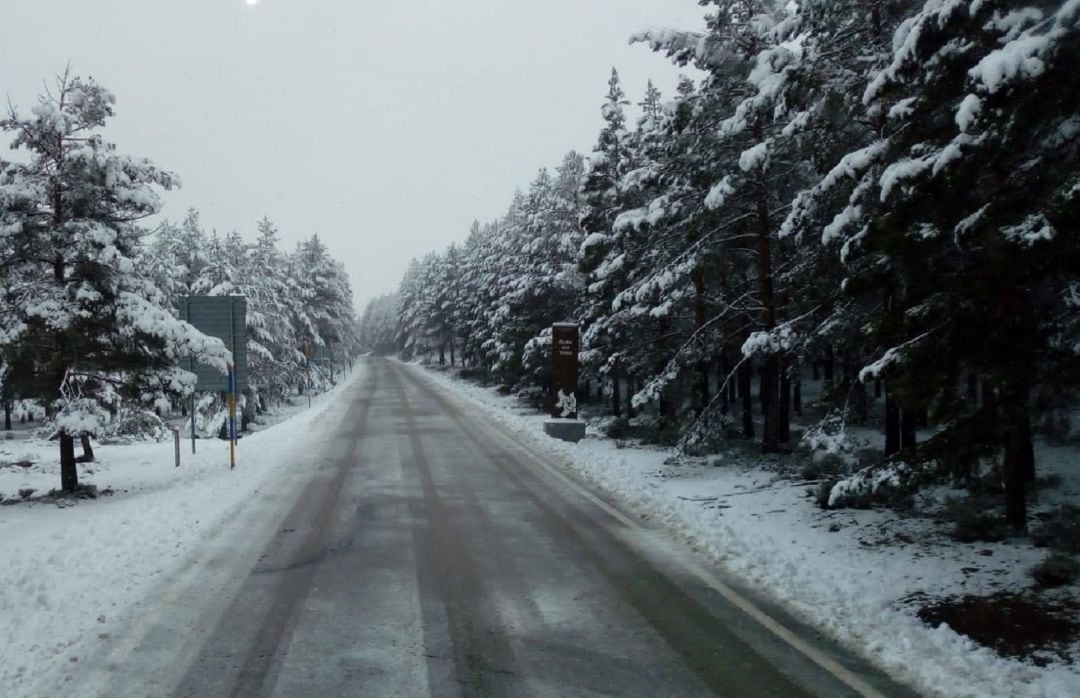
372,0,1080,535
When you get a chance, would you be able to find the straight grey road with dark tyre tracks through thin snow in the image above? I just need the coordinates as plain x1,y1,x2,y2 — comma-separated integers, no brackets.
90,359,908,697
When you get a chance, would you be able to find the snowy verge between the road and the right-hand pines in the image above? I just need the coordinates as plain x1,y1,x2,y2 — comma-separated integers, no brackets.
412,363,1080,697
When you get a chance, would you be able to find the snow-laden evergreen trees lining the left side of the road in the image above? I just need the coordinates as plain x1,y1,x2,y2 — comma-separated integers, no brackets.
0,69,356,491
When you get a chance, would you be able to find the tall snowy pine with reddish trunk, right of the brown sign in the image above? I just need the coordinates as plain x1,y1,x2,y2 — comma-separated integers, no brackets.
636,0,801,453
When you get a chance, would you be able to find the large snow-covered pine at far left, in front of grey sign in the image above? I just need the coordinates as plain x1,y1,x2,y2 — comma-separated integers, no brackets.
0,69,228,491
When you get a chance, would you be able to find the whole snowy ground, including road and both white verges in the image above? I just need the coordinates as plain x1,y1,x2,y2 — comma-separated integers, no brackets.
0,360,1077,696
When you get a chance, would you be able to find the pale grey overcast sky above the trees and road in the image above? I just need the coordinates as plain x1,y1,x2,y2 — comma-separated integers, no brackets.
0,0,703,310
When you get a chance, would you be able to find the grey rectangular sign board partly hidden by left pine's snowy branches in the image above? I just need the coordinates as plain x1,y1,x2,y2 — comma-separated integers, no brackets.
179,296,247,392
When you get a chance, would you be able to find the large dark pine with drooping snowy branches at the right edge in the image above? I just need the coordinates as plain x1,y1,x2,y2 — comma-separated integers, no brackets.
812,0,1080,528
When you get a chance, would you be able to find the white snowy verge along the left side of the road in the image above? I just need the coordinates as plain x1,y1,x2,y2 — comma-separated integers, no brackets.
0,363,365,696
